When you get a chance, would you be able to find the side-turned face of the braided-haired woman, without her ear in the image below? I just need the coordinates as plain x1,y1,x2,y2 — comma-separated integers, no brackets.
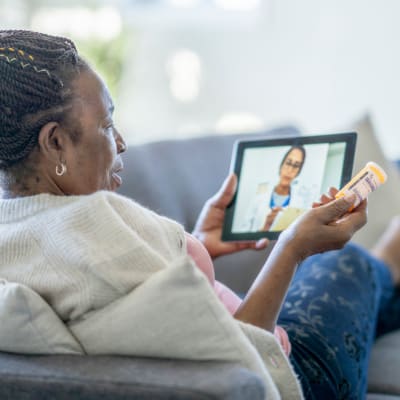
59,70,126,194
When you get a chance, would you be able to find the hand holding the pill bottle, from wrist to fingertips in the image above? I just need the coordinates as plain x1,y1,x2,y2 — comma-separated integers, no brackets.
279,189,367,262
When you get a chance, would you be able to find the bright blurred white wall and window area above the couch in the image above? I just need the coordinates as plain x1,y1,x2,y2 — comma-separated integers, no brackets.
0,0,400,159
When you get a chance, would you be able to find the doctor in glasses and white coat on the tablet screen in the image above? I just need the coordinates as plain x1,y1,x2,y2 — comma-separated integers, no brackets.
243,145,306,232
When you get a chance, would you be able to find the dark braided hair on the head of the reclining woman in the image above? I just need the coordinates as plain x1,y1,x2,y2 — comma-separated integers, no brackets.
0,30,88,170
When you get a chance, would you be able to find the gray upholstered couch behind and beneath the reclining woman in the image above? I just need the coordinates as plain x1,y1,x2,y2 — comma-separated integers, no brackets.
0,127,400,400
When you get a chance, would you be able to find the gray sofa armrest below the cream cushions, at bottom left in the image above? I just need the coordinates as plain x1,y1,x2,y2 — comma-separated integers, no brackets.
0,353,265,400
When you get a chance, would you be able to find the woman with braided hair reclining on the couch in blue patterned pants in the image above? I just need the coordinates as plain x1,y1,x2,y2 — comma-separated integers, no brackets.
0,31,400,399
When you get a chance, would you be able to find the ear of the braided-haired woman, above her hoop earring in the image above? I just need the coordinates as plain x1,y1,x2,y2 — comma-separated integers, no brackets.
38,121,67,163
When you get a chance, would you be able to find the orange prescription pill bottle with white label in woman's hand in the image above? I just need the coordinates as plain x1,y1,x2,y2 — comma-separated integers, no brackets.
335,161,387,211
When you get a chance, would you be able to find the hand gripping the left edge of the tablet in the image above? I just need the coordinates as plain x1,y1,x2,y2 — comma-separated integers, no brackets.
193,174,269,258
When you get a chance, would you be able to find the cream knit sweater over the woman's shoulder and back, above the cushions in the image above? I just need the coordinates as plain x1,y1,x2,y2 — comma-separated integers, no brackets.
0,191,186,321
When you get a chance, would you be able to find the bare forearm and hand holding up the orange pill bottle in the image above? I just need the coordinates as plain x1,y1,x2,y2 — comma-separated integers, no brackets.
235,191,367,332
